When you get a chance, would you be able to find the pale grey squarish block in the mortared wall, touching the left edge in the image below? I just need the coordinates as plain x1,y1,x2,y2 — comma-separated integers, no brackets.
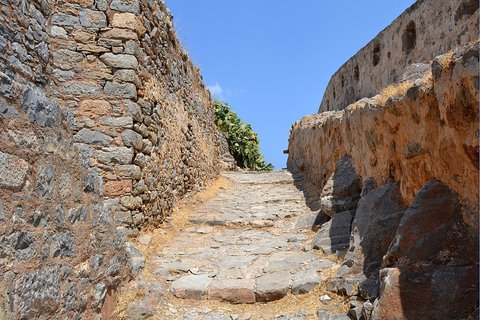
0,151,29,190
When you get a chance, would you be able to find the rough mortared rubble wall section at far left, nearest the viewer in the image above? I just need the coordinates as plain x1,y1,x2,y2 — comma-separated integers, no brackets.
0,1,129,319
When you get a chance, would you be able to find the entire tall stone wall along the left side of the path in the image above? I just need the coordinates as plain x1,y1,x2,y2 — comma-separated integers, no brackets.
0,0,228,319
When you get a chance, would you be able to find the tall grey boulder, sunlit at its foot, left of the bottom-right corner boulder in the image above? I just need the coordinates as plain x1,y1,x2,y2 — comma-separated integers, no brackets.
329,182,406,299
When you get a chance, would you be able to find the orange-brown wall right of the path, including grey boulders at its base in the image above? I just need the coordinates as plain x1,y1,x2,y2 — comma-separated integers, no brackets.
288,41,479,319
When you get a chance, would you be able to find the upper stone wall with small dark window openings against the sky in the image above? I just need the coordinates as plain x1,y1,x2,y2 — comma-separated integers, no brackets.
319,0,479,112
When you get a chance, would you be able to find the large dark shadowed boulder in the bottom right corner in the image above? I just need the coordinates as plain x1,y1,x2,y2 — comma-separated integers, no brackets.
373,180,478,319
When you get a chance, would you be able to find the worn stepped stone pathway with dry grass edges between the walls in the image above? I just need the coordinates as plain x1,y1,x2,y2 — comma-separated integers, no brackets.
115,171,348,320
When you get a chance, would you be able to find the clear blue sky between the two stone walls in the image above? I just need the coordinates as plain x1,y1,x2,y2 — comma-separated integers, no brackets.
166,0,415,169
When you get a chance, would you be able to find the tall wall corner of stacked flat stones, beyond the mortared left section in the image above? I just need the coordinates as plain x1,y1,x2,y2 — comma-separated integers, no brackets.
50,0,227,229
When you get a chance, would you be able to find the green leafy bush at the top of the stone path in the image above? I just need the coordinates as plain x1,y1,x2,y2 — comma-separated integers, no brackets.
213,100,273,171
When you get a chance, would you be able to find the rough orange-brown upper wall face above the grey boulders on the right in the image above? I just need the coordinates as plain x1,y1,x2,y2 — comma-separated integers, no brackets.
288,42,478,224
